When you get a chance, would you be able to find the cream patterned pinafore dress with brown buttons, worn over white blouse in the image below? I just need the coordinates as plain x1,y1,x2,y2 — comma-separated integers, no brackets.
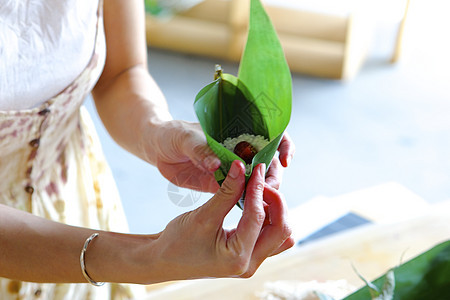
0,0,143,300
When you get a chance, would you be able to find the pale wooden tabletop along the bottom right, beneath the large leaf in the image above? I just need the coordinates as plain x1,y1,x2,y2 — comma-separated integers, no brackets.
146,186,450,300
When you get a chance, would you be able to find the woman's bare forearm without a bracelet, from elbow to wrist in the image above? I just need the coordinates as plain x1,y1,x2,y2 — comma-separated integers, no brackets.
93,65,172,164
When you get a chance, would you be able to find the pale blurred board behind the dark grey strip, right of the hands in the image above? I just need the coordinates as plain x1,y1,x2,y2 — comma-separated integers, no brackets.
289,182,430,241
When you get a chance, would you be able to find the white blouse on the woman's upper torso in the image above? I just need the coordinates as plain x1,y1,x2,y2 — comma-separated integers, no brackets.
0,0,98,110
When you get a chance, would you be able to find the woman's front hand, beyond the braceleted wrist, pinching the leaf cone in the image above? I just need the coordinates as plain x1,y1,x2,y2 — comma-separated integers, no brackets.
144,161,294,280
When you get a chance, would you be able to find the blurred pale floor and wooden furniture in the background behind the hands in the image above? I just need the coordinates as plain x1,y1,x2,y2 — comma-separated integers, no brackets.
86,0,450,233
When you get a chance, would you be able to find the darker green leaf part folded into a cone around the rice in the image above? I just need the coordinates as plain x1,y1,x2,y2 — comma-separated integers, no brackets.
194,74,268,182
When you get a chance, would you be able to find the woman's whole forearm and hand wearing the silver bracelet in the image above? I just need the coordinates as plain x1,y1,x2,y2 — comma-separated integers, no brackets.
0,161,294,284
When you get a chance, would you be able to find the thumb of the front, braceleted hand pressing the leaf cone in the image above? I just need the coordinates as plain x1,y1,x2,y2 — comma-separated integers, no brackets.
204,160,245,222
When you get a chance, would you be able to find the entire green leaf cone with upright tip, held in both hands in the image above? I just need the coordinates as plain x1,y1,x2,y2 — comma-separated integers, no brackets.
194,0,292,192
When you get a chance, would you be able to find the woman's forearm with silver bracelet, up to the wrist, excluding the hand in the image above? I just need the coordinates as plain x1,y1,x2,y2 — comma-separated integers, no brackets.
0,205,156,283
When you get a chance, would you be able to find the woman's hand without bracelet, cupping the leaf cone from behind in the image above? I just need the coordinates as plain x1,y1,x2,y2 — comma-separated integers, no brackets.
146,120,295,193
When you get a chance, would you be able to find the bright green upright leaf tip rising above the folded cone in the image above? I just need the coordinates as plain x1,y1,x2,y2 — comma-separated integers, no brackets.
238,0,292,139
